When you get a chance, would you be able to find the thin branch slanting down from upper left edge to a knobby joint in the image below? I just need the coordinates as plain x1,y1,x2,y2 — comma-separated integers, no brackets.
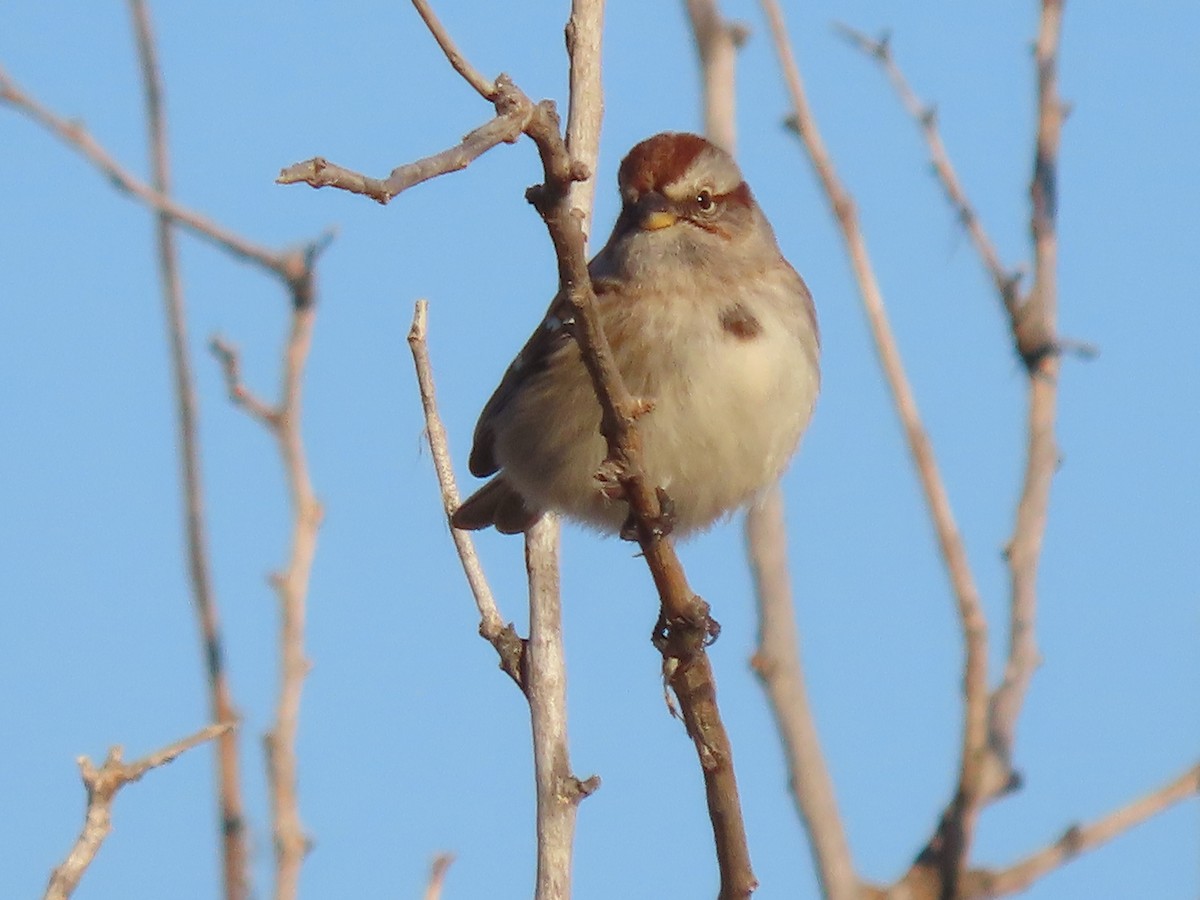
0,68,294,278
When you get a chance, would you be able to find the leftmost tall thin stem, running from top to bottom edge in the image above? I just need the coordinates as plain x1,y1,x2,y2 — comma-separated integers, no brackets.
130,0,248,900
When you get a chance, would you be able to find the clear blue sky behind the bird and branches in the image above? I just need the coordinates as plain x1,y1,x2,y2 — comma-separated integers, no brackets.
0,0,1200,900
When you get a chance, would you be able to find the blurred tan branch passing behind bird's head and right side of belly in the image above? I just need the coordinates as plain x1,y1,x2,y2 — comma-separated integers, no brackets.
688,0,862,900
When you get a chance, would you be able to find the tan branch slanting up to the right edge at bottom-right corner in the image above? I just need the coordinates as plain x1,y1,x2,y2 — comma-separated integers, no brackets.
964,764,1200,896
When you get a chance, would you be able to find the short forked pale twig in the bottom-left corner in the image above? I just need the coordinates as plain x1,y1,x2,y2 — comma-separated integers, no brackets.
44,721,234,900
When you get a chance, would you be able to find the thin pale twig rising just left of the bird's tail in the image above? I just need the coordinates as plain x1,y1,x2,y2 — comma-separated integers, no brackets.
408,300,524,690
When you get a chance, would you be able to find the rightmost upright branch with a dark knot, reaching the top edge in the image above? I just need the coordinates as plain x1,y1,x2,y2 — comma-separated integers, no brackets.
989,0,1063,787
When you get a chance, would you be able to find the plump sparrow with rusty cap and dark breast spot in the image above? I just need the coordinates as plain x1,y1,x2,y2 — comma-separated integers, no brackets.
451,132,821,538
